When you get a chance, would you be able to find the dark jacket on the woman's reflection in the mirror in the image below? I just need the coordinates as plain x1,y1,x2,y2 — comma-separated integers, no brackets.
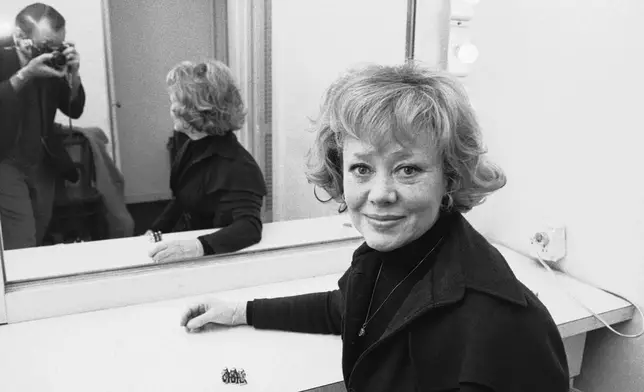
150,132,266,254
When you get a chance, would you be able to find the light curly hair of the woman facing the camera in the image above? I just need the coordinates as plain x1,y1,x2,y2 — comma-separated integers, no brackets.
307,62,506,213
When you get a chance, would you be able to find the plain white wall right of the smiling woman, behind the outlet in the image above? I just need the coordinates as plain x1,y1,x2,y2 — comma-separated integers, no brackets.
466,0,644,392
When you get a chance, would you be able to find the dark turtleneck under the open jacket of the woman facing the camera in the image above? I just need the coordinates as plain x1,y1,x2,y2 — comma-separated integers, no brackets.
357,213,450,352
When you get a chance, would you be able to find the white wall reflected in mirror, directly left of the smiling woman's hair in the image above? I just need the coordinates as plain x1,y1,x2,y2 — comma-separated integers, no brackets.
272,0,407,221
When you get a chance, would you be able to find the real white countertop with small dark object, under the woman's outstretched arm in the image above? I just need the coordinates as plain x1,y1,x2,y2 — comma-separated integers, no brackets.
0,243,633,392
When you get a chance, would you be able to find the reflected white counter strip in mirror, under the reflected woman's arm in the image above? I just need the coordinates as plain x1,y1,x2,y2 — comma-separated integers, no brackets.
4,215,361,282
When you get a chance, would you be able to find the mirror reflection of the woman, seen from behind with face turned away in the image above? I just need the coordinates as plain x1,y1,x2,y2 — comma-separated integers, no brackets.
150,61,266,262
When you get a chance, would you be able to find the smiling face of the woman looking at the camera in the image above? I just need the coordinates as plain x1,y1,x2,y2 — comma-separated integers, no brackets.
343,138,445,252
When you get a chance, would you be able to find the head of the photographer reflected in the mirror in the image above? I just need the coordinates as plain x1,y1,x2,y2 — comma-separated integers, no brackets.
14,3,66,58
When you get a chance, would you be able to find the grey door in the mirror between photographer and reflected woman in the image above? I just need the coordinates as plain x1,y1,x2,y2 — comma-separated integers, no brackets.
107,0,215,203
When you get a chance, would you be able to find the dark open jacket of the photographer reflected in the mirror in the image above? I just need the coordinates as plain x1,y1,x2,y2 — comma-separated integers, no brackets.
0,47,85,182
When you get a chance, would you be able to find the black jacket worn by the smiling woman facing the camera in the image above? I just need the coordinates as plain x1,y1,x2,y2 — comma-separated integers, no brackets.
247,214,569,392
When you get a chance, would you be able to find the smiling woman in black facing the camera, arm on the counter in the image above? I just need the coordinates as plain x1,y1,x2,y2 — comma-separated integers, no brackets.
176,65,568,392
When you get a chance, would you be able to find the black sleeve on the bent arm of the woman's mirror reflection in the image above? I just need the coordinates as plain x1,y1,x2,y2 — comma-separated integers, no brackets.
198,192,263,255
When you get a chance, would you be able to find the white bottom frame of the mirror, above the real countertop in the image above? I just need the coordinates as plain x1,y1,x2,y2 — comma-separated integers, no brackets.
6,239,362,323
